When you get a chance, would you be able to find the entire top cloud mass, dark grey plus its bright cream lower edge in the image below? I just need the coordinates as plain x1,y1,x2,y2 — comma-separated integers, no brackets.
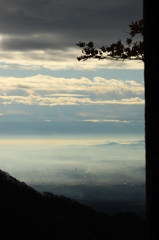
0,0,143,70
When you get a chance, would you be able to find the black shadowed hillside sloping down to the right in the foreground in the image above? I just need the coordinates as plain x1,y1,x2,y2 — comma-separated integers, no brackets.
0,170,145,240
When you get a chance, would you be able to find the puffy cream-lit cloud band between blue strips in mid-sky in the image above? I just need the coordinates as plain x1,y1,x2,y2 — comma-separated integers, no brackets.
0,75,144,106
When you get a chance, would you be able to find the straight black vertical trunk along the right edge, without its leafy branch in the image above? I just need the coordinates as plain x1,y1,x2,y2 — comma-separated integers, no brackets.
144,0,159,240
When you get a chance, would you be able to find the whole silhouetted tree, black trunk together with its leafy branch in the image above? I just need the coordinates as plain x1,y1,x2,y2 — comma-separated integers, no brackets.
77,8,159,240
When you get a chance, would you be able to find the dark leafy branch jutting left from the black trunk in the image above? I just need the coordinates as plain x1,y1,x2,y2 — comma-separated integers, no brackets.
76,19,144,61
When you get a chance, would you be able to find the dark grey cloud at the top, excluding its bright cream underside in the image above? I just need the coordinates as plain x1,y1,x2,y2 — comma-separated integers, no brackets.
0,0,143,50
